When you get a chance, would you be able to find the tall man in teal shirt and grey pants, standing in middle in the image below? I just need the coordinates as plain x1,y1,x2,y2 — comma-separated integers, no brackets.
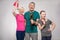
24,2,40,40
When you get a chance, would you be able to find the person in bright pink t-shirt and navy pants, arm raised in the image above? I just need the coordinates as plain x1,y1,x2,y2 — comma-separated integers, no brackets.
13,7,25,40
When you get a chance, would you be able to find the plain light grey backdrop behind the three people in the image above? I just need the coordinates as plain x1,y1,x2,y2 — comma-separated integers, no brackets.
0,0,60,40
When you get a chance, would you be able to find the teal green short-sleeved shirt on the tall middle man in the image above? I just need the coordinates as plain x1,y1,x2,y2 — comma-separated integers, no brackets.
24,11,40,33
